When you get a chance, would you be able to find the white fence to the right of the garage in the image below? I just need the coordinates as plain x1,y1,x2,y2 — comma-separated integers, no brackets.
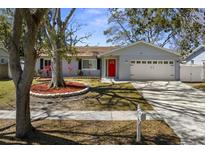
180,64,205,82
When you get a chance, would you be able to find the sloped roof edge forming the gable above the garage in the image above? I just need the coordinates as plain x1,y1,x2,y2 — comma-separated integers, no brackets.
99,41,179,57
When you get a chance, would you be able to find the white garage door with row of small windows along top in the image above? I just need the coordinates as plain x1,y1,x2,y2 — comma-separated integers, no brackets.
130,60,175,80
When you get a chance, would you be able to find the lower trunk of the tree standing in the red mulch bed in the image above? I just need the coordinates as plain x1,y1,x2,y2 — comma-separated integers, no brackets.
49,51,65,88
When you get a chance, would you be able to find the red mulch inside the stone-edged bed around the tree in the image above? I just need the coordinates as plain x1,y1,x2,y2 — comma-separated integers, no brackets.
31,82,86,94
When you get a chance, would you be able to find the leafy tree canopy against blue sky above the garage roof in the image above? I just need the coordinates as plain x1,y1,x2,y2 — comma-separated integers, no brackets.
104,8,205,55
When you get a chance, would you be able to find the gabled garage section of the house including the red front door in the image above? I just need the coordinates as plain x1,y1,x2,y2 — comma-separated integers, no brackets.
99,41,180,80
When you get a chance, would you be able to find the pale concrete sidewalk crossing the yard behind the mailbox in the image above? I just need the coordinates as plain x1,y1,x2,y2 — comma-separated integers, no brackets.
0,110,160,121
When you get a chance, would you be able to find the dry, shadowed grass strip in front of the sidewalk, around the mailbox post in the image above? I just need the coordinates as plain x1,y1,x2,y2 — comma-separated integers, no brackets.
0,120,180,145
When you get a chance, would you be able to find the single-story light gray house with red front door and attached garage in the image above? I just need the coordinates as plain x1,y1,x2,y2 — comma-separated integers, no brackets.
1,41,180,80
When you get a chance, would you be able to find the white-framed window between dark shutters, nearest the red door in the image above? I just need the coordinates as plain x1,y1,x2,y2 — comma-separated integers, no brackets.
82,59,97,70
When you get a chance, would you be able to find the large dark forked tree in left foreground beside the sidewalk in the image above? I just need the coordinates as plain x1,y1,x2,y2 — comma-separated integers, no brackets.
9,9,47,138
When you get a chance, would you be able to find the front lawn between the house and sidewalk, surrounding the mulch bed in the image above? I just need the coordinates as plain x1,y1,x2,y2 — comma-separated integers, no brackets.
0,78,153,111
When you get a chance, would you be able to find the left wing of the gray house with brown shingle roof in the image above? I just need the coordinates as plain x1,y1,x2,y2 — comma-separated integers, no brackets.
35,46,116,77
